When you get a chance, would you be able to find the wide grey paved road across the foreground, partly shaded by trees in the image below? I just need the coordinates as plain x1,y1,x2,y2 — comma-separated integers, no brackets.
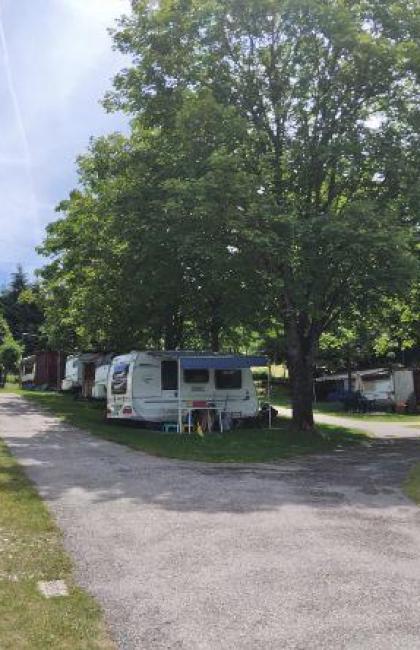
0,396,420,650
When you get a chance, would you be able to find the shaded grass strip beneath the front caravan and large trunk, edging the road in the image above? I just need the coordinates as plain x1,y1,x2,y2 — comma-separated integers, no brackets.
4,384,366,463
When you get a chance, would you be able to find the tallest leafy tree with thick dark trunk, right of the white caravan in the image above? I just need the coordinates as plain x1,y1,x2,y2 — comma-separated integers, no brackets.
106,0,420,428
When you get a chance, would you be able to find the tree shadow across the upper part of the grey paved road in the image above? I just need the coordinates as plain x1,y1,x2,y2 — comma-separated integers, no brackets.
0,396,420,513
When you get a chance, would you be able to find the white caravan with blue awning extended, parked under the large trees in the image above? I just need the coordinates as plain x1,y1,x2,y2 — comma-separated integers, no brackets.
107,352,267,431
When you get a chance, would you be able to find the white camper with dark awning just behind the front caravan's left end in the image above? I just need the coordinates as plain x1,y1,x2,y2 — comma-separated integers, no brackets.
61,352,112,398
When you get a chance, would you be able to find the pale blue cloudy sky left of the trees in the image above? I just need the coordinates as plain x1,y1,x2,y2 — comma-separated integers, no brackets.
0,0,129,285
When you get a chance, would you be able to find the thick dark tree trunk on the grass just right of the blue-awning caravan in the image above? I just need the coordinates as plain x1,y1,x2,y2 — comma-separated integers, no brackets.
286,322,316,431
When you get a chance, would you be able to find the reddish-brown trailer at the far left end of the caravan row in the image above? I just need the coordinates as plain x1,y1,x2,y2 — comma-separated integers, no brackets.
20,351,64,389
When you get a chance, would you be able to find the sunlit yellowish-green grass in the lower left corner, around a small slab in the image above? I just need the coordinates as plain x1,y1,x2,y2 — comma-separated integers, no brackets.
0,440,114,650
